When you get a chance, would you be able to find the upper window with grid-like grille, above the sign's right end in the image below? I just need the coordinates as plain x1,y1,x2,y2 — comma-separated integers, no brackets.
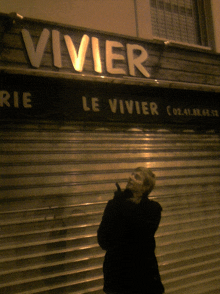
150,0,208,46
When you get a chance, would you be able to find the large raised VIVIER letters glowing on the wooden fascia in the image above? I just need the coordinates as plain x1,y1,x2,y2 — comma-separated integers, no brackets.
21,28,150,77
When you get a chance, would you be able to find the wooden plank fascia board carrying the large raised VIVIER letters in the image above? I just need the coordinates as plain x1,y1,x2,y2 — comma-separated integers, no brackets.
0,13,220,92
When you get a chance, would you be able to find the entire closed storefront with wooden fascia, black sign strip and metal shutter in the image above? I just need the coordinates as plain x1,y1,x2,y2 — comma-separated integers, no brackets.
0,15,220,294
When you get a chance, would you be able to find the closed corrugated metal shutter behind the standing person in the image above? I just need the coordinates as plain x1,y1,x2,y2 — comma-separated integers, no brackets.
0,124,220,294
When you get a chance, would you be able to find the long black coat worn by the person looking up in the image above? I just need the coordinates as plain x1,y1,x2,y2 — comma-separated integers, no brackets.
98,190,164,294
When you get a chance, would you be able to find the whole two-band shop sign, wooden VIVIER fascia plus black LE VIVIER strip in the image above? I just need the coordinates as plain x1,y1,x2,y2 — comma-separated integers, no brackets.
0,16,220,127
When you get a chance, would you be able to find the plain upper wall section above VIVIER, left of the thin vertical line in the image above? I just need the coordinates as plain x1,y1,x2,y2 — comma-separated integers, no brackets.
0,0,136,36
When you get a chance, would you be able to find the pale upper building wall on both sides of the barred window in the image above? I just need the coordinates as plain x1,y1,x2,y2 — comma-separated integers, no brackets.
0,0,220,52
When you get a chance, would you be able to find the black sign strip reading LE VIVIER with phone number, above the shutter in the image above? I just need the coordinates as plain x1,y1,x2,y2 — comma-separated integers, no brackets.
0,75,220,128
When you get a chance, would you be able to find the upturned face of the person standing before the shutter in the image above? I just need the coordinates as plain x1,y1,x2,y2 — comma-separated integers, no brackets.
126,171,145,193
